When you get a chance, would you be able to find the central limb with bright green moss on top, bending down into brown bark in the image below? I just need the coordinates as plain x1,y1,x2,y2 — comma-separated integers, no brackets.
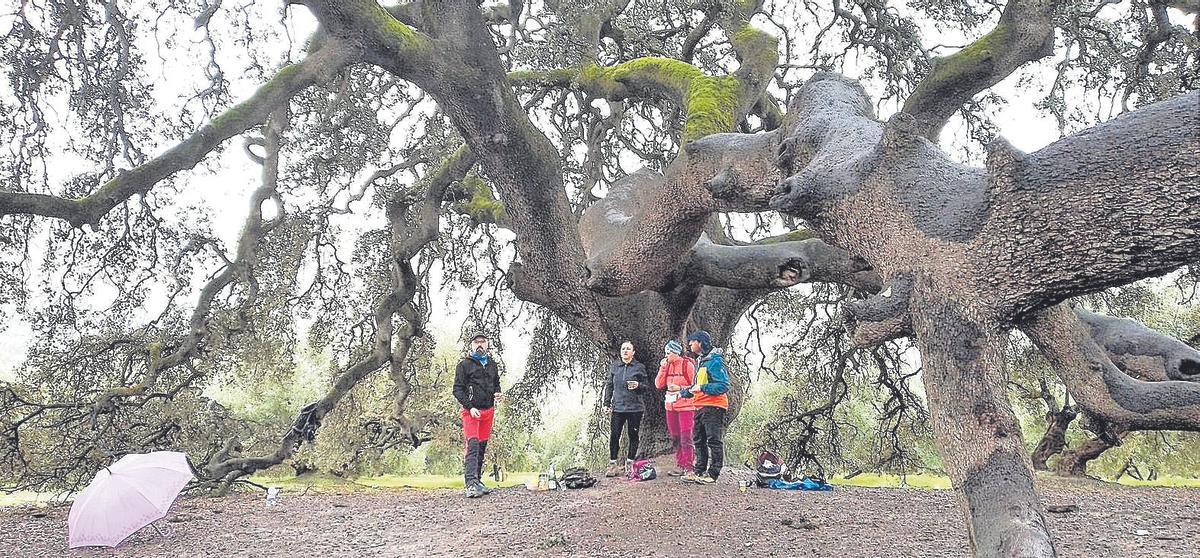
510,2,779,296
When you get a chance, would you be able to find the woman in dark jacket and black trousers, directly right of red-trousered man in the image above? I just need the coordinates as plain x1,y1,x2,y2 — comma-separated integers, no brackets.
604,341,649,476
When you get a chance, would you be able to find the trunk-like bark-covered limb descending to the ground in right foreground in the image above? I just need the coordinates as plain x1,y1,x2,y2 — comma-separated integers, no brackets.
912,286,1056,558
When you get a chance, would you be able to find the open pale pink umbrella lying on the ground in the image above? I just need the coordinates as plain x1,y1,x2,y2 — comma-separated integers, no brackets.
67,451,192,548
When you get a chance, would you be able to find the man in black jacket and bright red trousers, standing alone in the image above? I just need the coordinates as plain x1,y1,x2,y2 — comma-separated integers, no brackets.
454,334,504,498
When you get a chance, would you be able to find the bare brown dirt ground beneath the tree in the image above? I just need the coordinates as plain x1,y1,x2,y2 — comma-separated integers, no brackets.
0,475,1200,558
